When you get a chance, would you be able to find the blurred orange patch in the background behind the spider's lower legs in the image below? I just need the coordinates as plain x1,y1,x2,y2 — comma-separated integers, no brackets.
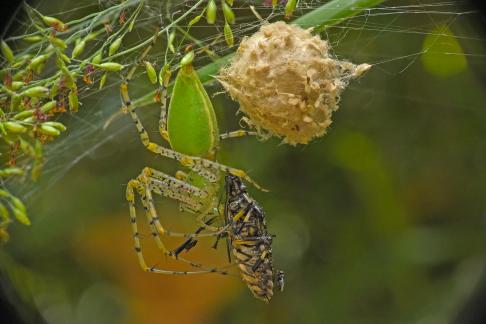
75,212,244,324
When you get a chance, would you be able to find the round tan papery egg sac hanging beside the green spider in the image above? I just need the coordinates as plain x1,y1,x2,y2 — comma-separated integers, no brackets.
218,21,371,145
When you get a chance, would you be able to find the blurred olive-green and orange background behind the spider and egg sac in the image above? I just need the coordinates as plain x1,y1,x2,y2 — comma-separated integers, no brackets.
0,1,486,324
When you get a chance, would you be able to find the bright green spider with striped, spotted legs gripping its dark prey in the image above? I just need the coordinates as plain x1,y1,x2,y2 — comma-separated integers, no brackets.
120,43,264,275
